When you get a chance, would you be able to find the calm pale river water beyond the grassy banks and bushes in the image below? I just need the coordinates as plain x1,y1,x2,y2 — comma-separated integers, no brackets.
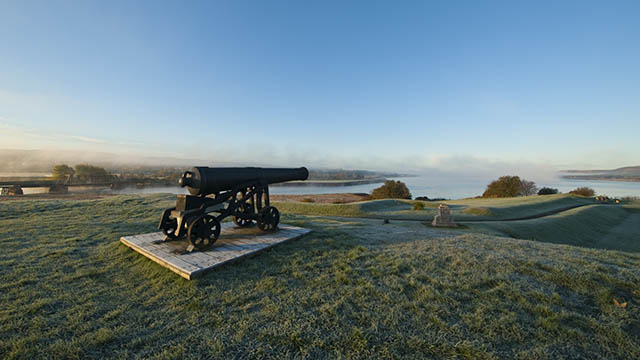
113,176,640,199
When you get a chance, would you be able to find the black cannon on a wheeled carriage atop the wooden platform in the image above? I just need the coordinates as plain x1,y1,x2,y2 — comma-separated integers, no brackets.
158,166,309,251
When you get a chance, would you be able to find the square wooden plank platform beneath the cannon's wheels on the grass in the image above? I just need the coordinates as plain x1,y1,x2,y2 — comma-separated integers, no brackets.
120,222,311,280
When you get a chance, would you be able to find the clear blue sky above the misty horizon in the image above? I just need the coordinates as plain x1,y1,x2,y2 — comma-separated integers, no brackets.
0,0,640,169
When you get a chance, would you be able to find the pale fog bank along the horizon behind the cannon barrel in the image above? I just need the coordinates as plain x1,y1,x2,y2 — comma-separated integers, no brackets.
0,144,570,181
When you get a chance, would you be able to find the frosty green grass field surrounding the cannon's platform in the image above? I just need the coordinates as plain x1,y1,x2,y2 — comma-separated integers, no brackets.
0,195,640,359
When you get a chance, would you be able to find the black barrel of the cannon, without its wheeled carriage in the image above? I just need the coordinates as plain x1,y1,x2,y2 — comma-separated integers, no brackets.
178,166,309,196
